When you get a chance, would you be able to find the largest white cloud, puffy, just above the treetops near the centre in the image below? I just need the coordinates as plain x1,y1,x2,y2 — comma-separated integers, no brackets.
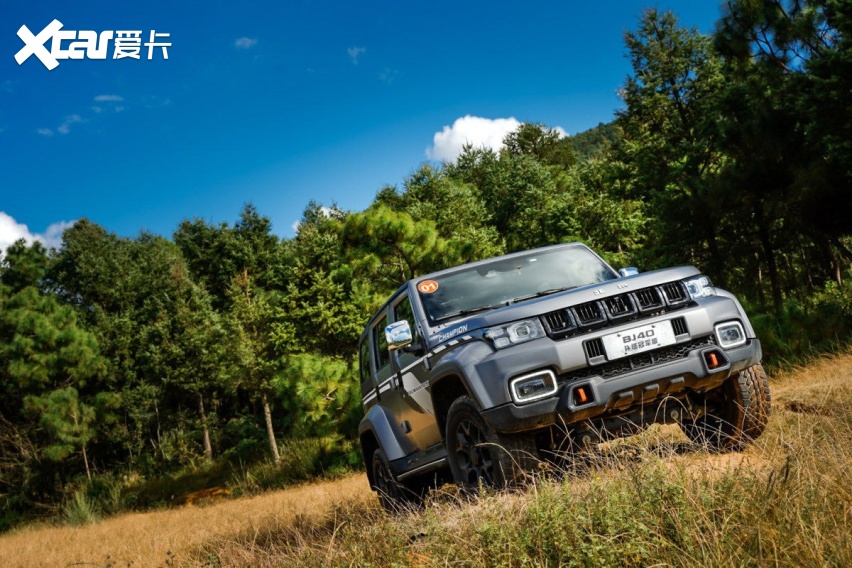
426,115,521,161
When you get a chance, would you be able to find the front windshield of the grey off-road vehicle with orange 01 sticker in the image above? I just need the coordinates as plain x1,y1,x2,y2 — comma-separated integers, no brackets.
417,247,618,325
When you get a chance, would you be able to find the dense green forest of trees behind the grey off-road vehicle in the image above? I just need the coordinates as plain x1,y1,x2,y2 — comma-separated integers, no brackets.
5,0,852,528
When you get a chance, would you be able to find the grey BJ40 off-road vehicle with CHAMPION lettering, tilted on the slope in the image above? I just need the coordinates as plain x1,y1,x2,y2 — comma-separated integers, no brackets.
359,243,770,508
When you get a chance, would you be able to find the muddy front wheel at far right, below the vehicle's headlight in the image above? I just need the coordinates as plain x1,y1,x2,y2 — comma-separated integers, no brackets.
680,364,772,450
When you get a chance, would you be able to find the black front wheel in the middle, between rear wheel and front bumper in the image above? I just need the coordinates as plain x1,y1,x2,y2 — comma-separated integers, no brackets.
444,396,538,489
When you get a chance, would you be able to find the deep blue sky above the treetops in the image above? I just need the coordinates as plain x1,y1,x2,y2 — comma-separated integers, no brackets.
0,0,721,246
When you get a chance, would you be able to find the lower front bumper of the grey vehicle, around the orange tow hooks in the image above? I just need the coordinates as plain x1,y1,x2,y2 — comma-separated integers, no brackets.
482,339,762,433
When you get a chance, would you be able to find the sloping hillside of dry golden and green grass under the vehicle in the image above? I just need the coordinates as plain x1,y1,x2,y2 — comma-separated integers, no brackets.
0,354,852,567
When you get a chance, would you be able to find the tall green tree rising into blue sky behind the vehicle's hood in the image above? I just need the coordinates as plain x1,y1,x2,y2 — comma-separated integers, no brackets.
616,9,726,278
